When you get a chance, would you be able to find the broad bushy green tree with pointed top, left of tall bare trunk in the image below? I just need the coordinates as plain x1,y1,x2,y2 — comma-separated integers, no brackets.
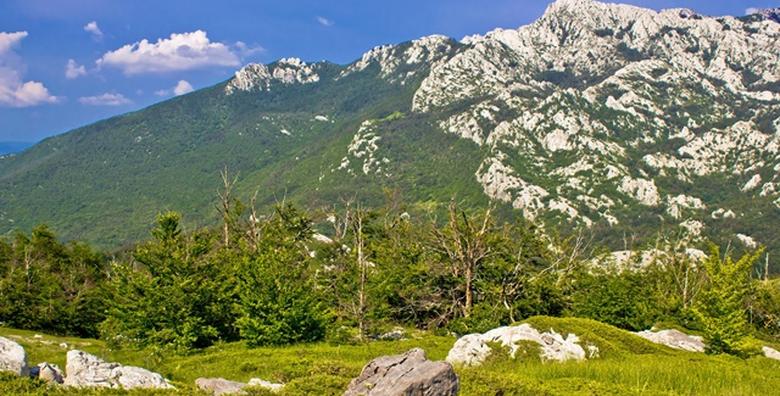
100,213,232,352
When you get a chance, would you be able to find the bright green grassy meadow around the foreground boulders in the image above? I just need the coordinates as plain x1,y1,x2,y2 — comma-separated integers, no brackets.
0,317,780,395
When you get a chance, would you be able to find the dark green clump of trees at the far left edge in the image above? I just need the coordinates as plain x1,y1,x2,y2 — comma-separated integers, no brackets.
0,226,109,337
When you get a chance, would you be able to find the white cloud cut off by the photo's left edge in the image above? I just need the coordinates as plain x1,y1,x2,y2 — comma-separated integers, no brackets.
0,32,57,107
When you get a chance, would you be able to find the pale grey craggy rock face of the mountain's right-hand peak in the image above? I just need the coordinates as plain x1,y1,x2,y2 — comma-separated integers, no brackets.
402,0,780,235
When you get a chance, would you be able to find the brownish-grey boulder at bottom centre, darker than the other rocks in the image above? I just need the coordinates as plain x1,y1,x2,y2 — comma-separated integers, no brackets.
344,348,459,396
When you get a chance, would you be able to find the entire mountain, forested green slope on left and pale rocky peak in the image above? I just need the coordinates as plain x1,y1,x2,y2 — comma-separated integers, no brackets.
0,0,780,260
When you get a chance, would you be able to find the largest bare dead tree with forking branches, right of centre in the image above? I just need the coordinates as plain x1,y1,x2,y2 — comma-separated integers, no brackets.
433,200,492,317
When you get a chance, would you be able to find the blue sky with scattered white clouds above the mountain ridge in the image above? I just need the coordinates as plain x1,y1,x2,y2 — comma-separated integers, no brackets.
0,0,780,141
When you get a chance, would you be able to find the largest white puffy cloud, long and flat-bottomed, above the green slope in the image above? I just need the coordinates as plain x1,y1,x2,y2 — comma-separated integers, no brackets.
97,30,241,75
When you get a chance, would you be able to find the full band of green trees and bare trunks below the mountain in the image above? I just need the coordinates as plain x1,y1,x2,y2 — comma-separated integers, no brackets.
0,183,780,354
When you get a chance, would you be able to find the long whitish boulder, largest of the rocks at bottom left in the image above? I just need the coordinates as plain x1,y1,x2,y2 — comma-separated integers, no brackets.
64,350,173,389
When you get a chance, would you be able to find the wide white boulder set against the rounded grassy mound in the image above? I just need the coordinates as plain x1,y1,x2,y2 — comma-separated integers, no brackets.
447,323,598,366
